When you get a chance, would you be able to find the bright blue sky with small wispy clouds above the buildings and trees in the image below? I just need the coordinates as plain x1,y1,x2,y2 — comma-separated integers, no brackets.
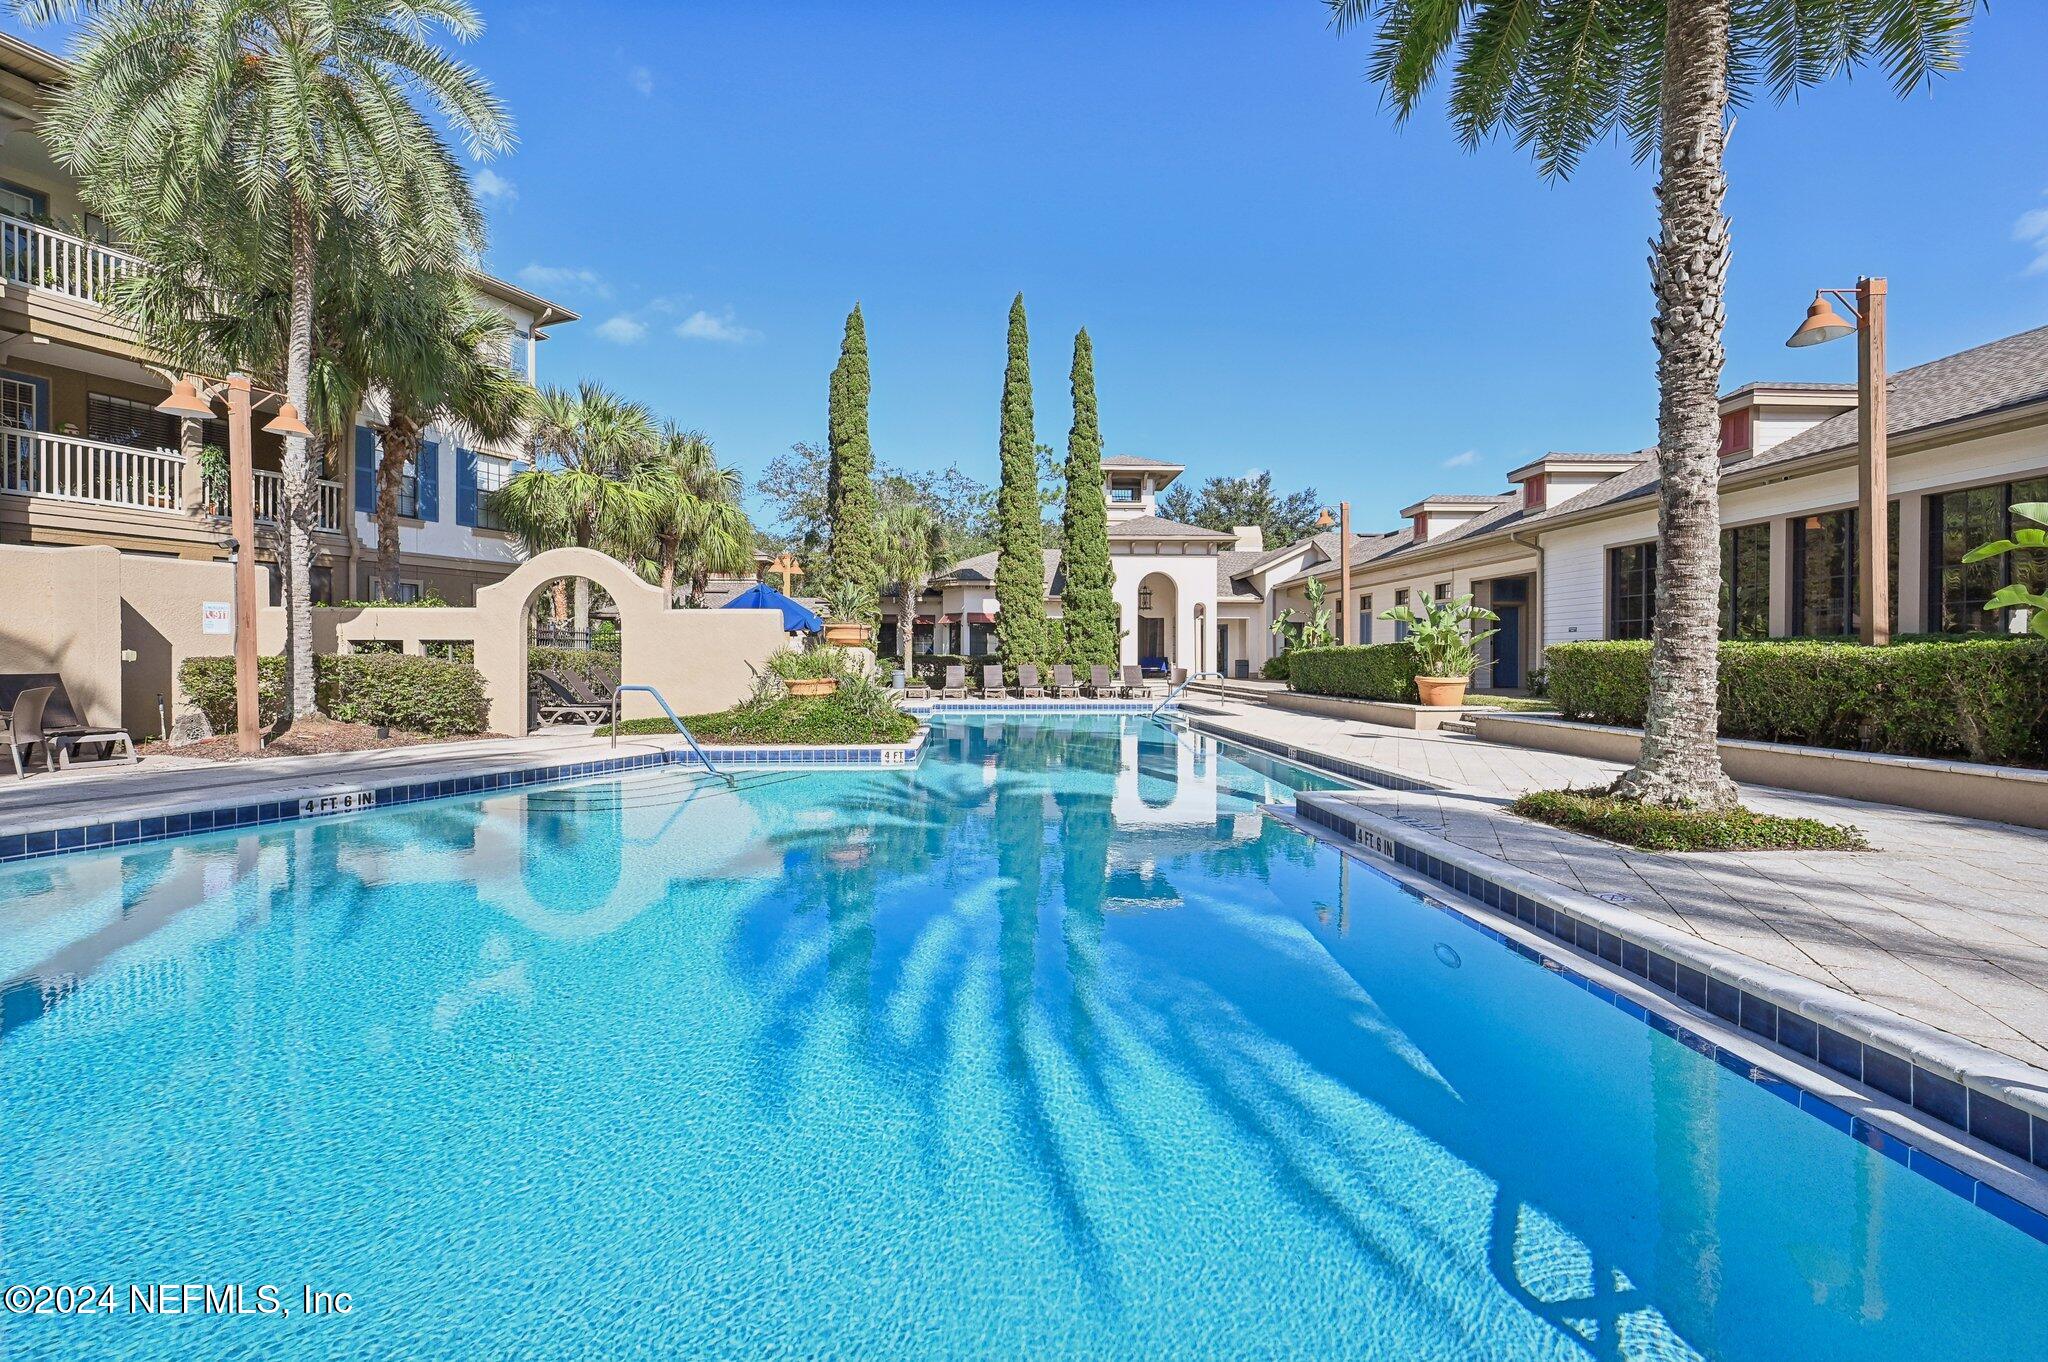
8,0,2048,524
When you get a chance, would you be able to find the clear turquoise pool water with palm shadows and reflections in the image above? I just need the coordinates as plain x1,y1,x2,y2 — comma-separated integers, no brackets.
0,719,2048,1362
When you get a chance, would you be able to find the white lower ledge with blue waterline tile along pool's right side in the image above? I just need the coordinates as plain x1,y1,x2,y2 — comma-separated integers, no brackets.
1264,805,2048,1243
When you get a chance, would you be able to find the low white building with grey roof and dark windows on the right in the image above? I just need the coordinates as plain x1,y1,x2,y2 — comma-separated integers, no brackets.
1274,328,2048,690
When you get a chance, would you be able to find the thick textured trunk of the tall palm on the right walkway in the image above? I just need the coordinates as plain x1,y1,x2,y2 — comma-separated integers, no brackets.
1614,0,1735,807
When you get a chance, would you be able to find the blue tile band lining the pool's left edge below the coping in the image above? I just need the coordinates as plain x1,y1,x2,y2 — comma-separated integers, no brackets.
0,729,926,864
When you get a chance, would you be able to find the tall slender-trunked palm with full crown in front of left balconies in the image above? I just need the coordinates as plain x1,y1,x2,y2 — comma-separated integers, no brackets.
14,0,512,715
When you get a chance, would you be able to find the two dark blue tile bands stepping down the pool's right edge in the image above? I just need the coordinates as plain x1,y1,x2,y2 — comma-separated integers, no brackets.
1277,798,2048,1243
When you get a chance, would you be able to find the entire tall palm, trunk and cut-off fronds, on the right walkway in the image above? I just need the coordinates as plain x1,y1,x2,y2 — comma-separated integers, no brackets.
1325,0,1976,807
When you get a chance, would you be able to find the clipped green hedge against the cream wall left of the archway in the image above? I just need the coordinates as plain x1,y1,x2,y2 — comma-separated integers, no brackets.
178,653,489,737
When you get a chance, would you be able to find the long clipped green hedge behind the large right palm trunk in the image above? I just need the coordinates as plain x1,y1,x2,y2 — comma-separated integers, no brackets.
1546,639,2048,766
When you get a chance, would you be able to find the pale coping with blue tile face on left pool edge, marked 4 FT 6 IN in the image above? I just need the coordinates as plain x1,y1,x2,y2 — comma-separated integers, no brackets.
0,727,930,866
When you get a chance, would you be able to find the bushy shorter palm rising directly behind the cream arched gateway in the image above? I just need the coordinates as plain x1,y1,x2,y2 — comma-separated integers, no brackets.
492,383,657,633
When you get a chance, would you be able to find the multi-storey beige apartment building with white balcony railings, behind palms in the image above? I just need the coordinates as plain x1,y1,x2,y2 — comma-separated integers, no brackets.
0,35,575,604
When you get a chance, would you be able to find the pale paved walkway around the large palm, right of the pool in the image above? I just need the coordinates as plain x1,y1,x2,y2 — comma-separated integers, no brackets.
1190,698,2048,1071
